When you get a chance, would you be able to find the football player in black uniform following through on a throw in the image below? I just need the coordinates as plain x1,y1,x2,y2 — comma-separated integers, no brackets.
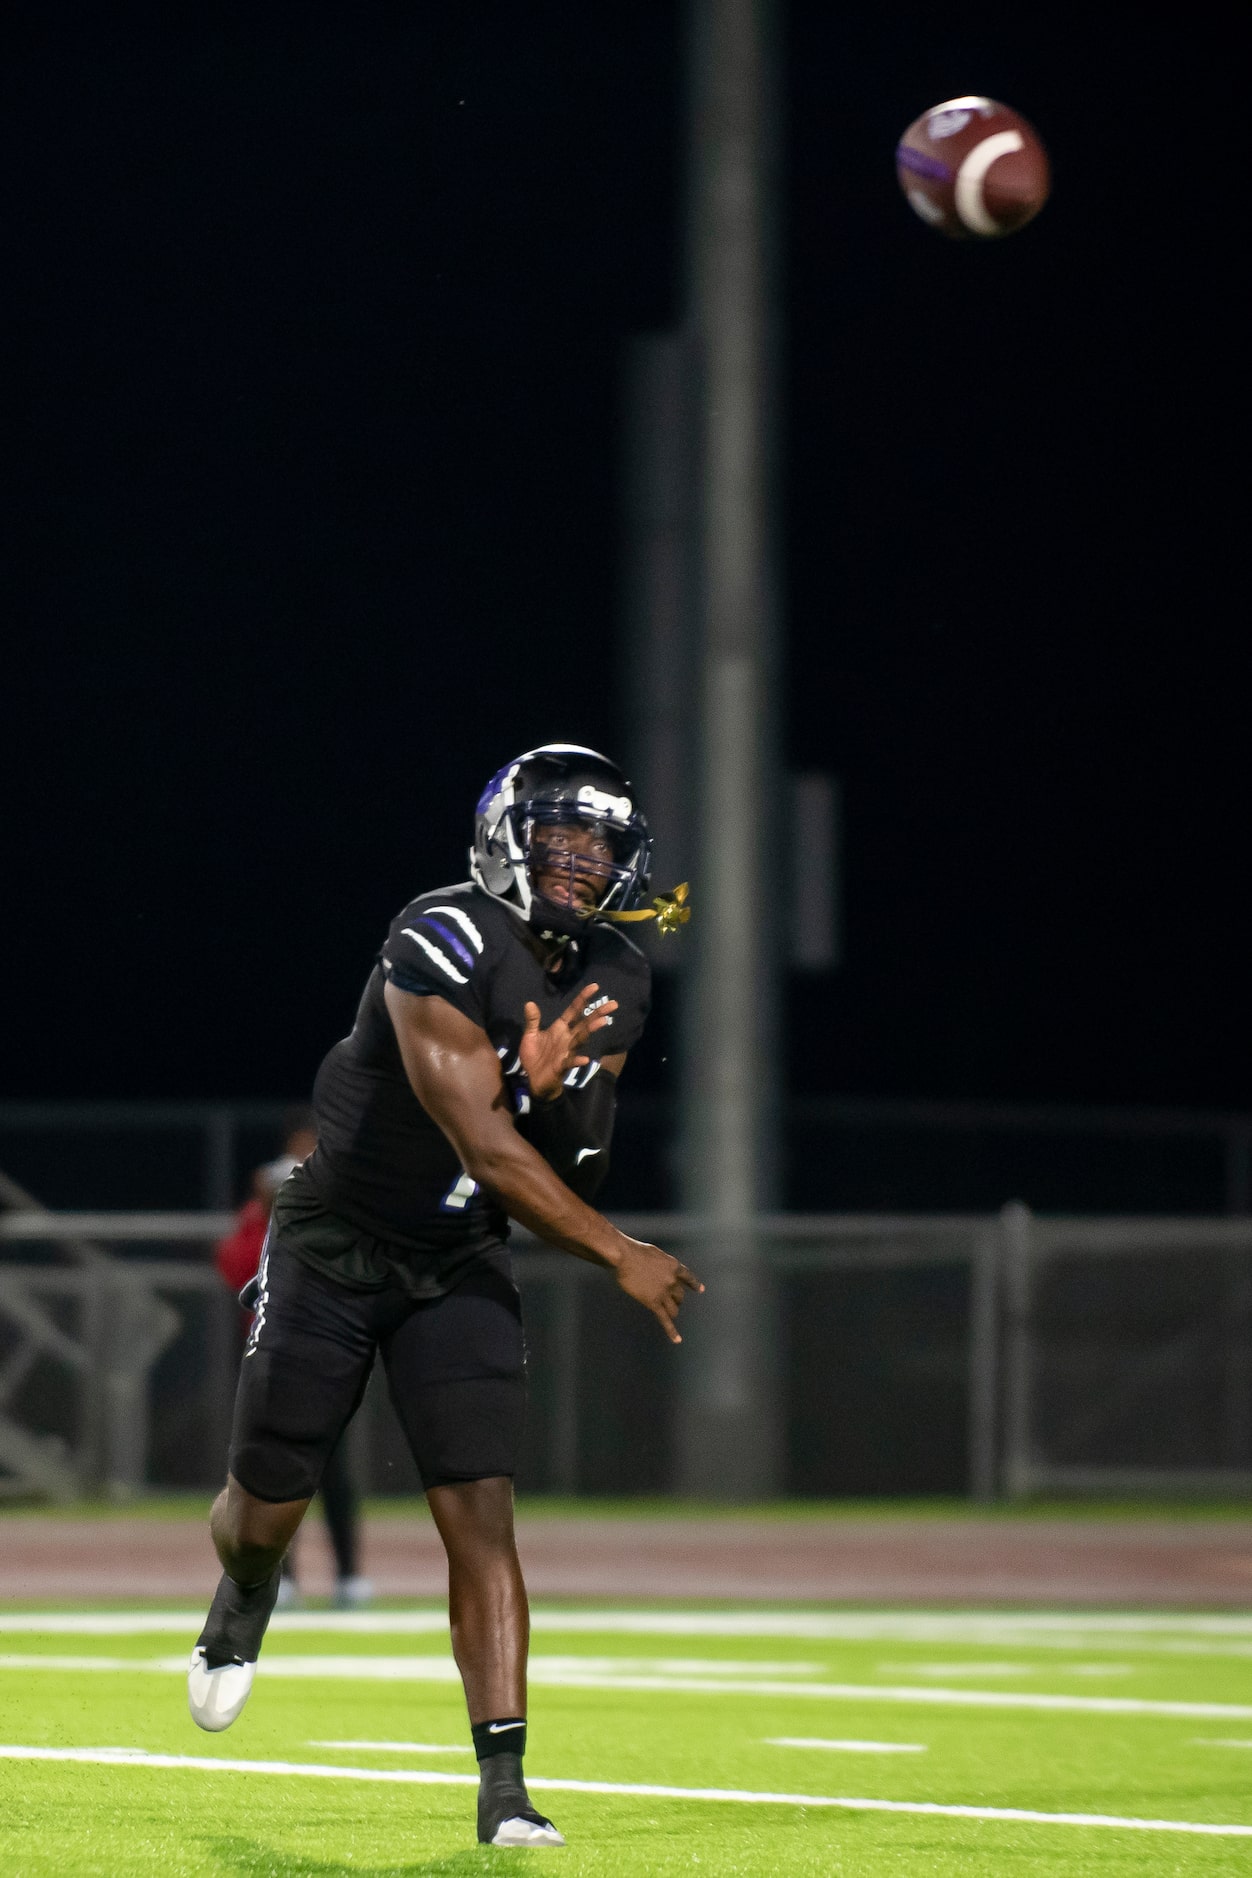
188,744,702,1846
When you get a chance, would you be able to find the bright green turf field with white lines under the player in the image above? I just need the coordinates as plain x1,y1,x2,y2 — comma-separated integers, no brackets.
0,1606,1252,1878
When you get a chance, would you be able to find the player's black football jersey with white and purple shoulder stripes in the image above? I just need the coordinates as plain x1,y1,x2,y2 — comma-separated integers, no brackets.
304,881,649,1266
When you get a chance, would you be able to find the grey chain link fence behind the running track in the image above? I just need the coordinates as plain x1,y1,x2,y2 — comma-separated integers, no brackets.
0,1206,1252,1501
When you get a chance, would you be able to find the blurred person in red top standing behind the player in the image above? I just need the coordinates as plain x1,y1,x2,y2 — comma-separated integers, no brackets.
214,1108,374,1611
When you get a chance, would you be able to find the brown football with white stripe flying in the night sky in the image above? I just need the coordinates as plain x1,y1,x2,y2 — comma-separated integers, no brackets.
895,98,1051,240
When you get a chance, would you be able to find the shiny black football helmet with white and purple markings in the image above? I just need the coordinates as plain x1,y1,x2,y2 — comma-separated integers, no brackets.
469,744,651,939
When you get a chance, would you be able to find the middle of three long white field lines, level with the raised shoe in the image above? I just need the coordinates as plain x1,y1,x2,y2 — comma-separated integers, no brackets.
0,1655,1252,1722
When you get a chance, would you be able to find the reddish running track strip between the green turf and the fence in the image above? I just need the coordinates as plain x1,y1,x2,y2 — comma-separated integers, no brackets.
0,1508,1252,1608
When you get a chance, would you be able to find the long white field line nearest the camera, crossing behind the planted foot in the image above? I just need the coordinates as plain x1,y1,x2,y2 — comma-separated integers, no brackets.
0,1745,1252,1839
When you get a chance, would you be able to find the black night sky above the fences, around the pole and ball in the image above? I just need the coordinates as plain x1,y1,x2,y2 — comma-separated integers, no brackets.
0,0,1252,1106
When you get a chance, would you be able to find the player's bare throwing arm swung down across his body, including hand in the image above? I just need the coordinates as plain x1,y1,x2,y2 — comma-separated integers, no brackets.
385,984,704,1343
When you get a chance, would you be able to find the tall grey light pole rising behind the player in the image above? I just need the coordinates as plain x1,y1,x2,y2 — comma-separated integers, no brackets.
676,0,785,1497
